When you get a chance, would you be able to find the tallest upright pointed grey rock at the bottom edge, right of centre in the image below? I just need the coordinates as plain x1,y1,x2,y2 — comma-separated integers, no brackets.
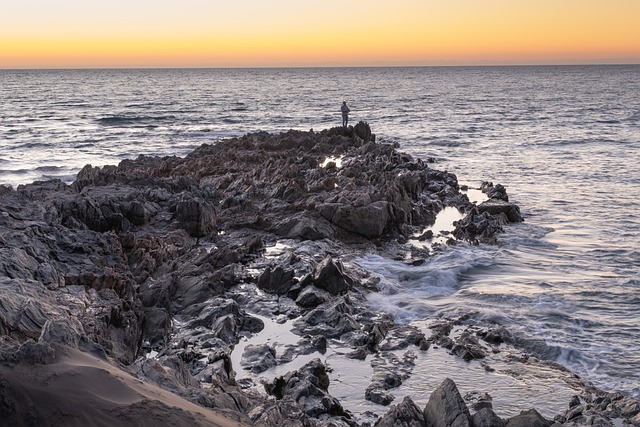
424,378,471,427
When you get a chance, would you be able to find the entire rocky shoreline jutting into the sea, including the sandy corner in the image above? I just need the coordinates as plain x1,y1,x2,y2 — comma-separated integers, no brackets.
0,122,640,426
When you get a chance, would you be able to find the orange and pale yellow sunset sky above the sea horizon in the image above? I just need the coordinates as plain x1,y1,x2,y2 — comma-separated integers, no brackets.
0,0,640,69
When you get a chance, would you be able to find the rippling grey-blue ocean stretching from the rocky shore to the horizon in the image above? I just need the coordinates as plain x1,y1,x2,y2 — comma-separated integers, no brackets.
0,65,640,398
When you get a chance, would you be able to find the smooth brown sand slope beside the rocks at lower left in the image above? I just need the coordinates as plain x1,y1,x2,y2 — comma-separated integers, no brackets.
0,348,251,427
